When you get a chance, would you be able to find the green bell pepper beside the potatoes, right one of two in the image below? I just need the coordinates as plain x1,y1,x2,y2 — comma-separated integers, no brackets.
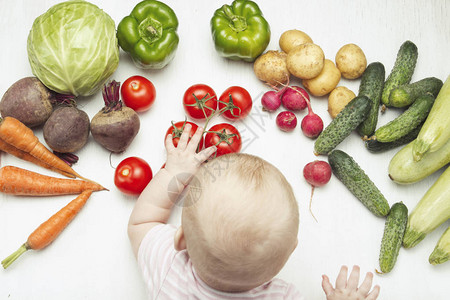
211,0,270,62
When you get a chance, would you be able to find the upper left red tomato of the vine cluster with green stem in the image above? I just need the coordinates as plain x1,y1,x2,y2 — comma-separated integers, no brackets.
183,84,217,120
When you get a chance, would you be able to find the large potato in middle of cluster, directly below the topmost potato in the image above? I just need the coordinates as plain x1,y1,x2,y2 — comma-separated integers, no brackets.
286,43,325,79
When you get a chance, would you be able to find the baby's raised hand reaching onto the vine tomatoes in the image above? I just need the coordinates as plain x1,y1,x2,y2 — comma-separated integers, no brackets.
164,123,217,185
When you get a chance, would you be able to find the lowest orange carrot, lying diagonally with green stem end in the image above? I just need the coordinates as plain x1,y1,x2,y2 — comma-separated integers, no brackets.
2,190,92,269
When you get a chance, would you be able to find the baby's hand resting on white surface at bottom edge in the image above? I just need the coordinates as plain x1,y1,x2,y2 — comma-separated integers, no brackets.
322,266,380,300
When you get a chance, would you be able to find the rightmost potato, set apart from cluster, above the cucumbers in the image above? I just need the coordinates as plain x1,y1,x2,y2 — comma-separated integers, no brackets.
335,44,367,79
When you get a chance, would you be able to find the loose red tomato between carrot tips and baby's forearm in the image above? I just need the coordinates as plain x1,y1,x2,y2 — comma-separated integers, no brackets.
114,156,153,195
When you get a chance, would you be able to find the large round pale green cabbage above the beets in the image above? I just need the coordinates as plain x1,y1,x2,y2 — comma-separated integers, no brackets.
27,0,119,96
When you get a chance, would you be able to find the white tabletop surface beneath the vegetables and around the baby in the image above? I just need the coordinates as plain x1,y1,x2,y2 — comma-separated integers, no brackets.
0,0,450,300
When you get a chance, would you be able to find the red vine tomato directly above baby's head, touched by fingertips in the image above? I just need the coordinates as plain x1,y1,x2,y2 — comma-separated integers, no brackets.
205,123,242,156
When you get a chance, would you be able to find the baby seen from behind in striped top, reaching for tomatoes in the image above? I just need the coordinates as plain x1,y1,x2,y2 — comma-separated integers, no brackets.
128,124,379,300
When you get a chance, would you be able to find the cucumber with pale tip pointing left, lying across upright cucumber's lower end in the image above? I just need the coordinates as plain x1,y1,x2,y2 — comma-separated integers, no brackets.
389,77,443,107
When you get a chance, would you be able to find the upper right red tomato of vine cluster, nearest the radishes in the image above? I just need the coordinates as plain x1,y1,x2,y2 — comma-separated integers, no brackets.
219,86,253,120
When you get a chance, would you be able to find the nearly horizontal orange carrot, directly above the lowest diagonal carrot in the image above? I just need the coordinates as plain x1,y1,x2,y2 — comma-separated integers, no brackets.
0,166,105,196
